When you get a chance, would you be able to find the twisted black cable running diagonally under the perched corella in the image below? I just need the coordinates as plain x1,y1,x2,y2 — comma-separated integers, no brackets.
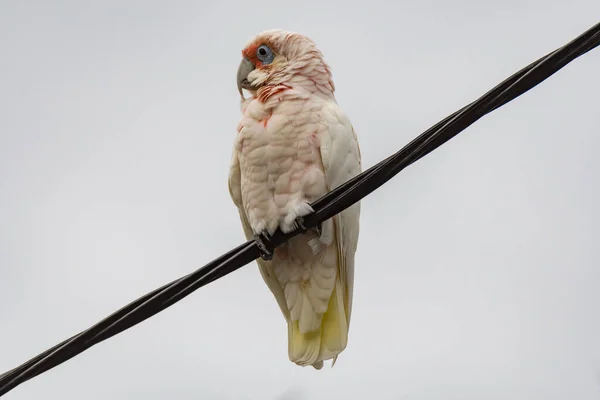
0,24,600,396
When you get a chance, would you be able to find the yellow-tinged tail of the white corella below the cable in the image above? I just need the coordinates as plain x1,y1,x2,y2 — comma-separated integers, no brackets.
288,279,348,369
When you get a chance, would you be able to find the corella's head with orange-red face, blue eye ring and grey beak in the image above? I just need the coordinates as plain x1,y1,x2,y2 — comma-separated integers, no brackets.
237,29,335,101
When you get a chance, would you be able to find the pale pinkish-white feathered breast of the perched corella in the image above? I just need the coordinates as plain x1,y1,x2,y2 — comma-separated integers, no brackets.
236,100,326,231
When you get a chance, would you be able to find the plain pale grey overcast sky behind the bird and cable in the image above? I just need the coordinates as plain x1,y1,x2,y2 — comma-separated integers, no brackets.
0,0,600,400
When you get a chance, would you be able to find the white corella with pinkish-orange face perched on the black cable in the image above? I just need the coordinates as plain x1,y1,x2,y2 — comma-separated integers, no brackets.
229,30,361,369
